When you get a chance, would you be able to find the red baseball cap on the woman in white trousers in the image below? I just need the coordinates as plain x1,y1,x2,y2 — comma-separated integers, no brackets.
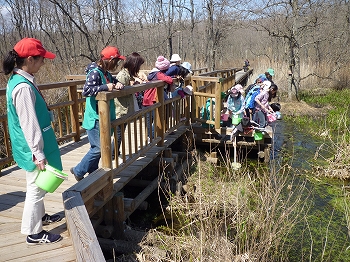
13,38,56,59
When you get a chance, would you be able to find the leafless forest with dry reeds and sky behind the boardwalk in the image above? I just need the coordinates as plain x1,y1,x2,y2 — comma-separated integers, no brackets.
0,0,350,100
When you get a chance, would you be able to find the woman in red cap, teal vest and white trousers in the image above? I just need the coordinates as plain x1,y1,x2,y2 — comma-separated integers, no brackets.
3,38,62,245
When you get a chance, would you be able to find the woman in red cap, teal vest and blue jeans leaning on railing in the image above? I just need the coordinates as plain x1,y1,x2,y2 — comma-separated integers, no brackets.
70,46,125,181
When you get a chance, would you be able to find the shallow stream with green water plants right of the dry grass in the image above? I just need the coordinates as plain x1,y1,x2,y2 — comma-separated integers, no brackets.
271,121,350,262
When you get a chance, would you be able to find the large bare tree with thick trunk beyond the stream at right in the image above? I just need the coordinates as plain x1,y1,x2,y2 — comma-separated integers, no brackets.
242,0,346,99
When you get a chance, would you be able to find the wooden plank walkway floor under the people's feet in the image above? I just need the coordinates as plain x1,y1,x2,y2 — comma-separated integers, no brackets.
0,127,190,262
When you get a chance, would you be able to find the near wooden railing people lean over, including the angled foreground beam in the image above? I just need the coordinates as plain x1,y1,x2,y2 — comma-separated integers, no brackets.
59,81,190,261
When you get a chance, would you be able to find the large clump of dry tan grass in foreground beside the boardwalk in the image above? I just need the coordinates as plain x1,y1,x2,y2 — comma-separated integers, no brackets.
138,151,305,262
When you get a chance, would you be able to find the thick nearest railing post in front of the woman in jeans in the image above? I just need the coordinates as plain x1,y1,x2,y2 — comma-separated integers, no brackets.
98,99,113,169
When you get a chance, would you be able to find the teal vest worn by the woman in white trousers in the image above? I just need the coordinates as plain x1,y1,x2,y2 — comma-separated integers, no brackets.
6,74,62,171
